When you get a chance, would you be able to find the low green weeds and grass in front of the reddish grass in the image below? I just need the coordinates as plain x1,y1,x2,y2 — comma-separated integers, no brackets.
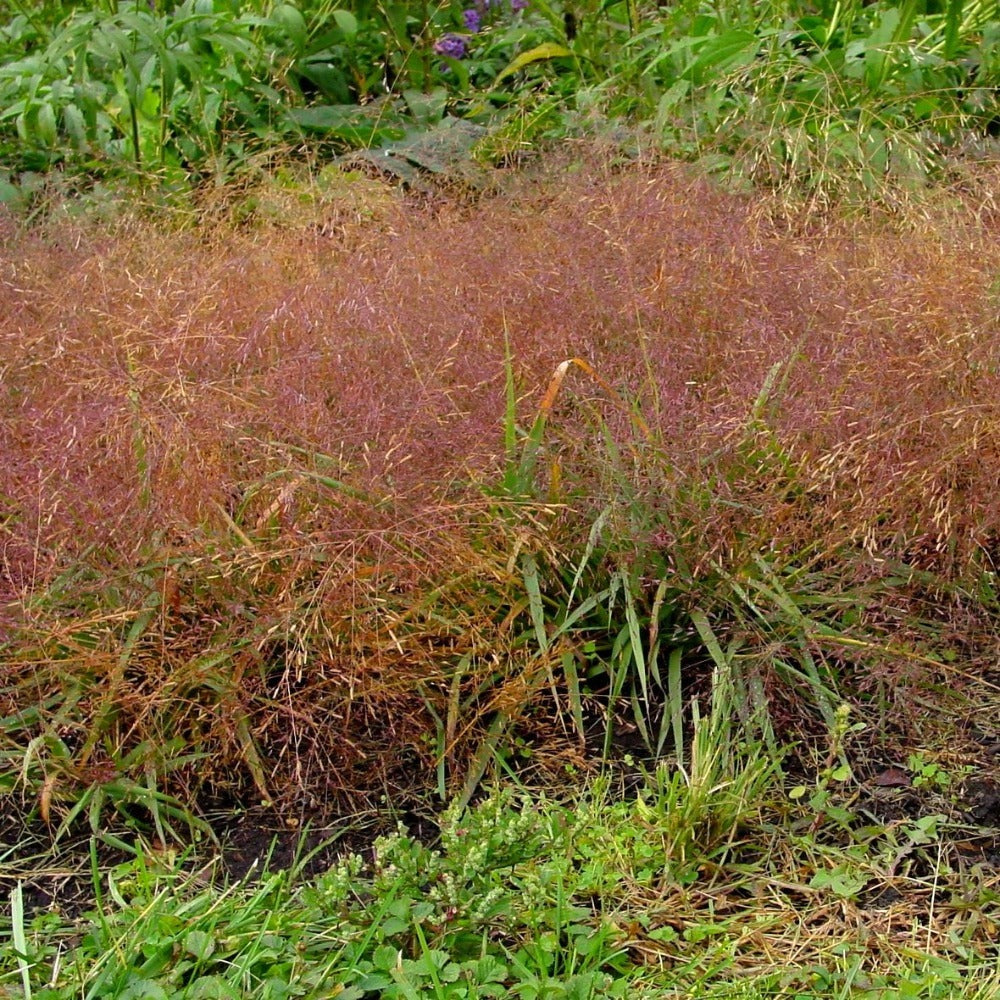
0,756,1000,1000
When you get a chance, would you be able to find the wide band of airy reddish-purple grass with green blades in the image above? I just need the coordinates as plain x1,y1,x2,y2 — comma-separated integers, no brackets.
0,160,1000,820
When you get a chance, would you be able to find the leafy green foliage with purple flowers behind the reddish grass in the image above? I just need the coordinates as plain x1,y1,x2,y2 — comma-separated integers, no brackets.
0,0,1000,197
